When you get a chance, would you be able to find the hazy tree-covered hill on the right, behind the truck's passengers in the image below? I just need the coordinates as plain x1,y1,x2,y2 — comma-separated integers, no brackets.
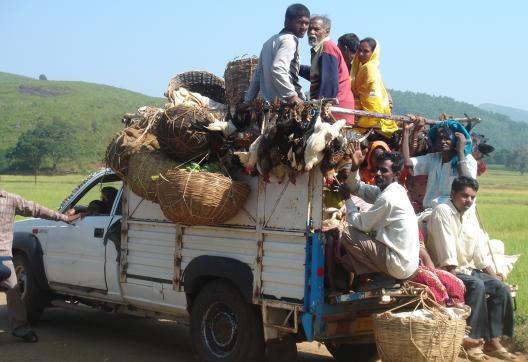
391,90,528,150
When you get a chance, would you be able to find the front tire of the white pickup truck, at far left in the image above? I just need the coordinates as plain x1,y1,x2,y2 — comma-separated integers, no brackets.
13,253,44,325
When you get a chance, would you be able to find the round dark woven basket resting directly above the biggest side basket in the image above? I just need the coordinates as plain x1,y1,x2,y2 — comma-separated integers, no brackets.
156,104,213,161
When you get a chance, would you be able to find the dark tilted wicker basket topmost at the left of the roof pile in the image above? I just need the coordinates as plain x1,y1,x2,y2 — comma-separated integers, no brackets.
165,70,225,103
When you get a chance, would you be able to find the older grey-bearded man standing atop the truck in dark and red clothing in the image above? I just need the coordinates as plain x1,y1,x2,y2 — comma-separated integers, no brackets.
300,15,354,124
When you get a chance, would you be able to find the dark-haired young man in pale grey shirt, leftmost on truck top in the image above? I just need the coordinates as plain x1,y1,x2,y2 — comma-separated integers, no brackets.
242,4,310,108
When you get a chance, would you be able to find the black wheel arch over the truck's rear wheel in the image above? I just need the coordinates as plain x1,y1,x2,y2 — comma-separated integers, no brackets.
183,255,253,303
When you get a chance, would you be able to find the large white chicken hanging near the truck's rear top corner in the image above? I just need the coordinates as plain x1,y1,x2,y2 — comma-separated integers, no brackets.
304,116,346,171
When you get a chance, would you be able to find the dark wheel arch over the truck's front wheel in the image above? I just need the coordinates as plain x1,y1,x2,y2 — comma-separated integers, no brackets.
12,232,49,289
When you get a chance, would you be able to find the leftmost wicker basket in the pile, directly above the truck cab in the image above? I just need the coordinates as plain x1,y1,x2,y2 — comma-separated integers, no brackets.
105,127,160,178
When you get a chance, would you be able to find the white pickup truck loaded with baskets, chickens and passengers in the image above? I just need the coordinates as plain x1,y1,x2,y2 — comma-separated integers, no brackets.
13,169,416,361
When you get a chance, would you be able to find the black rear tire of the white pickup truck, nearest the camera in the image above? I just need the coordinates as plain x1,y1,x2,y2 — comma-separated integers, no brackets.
191,280,264,362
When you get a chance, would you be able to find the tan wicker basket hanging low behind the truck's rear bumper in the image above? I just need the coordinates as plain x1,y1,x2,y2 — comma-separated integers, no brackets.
372,300,469,362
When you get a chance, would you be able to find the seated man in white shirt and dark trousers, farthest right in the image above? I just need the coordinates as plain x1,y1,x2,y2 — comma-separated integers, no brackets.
427,176,514,360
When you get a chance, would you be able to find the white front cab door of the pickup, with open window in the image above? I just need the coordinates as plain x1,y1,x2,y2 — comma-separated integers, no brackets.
44,177,121,291
